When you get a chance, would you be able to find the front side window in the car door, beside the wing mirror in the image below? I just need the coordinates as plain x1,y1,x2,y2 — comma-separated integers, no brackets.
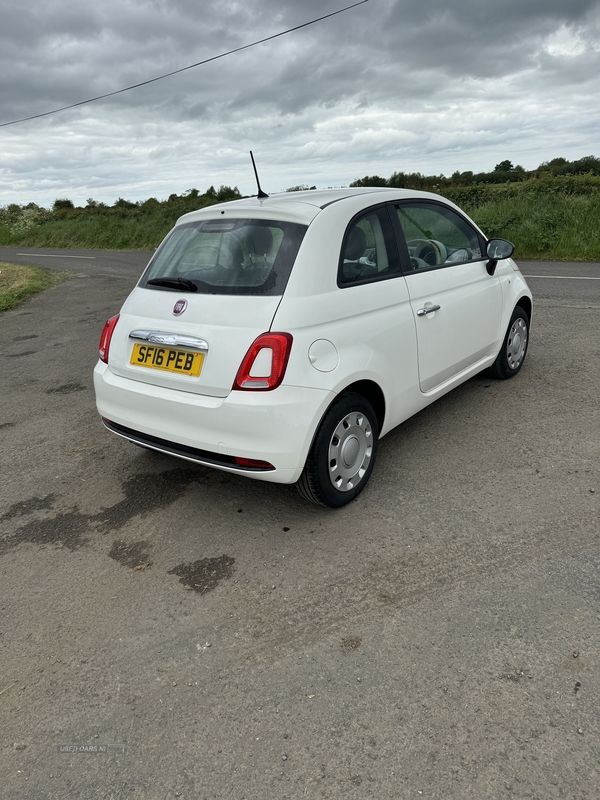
396,203,483,270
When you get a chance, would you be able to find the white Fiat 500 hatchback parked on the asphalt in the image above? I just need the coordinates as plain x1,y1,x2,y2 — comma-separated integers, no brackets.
94,188,532,508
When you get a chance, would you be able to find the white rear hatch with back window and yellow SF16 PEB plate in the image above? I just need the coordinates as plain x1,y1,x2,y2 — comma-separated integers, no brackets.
103,214,306,397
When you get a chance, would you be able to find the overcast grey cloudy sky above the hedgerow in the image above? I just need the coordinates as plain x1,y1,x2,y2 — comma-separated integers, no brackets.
0,0,600,206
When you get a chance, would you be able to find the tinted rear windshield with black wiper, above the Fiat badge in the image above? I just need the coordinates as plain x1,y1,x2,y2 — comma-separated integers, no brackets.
140,219,306,295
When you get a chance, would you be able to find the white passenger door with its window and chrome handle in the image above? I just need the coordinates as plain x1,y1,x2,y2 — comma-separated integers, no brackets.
393,201,502,393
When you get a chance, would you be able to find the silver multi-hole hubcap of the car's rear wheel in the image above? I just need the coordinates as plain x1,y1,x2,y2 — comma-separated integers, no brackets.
328,411,373,492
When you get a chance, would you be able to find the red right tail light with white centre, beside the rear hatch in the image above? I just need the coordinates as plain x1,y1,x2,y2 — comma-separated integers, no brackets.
233,333,292,392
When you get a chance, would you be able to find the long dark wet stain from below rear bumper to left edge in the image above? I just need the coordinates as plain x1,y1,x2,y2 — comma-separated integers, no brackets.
0,467,206,555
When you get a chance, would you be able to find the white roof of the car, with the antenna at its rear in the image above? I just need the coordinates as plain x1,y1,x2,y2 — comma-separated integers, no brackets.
177,186,448,225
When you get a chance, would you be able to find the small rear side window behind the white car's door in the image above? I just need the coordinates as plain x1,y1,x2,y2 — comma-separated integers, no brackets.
338,208,398,287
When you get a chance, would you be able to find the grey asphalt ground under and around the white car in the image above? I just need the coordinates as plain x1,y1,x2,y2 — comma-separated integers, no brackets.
0,248,600,800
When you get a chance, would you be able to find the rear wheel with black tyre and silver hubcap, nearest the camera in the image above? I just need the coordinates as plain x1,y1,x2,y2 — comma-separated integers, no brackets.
297,392,379,508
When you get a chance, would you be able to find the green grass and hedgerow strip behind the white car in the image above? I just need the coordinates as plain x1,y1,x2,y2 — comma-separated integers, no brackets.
0,174,600,261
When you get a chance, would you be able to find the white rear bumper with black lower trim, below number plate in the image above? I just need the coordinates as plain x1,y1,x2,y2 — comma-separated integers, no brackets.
94,362,334,483
